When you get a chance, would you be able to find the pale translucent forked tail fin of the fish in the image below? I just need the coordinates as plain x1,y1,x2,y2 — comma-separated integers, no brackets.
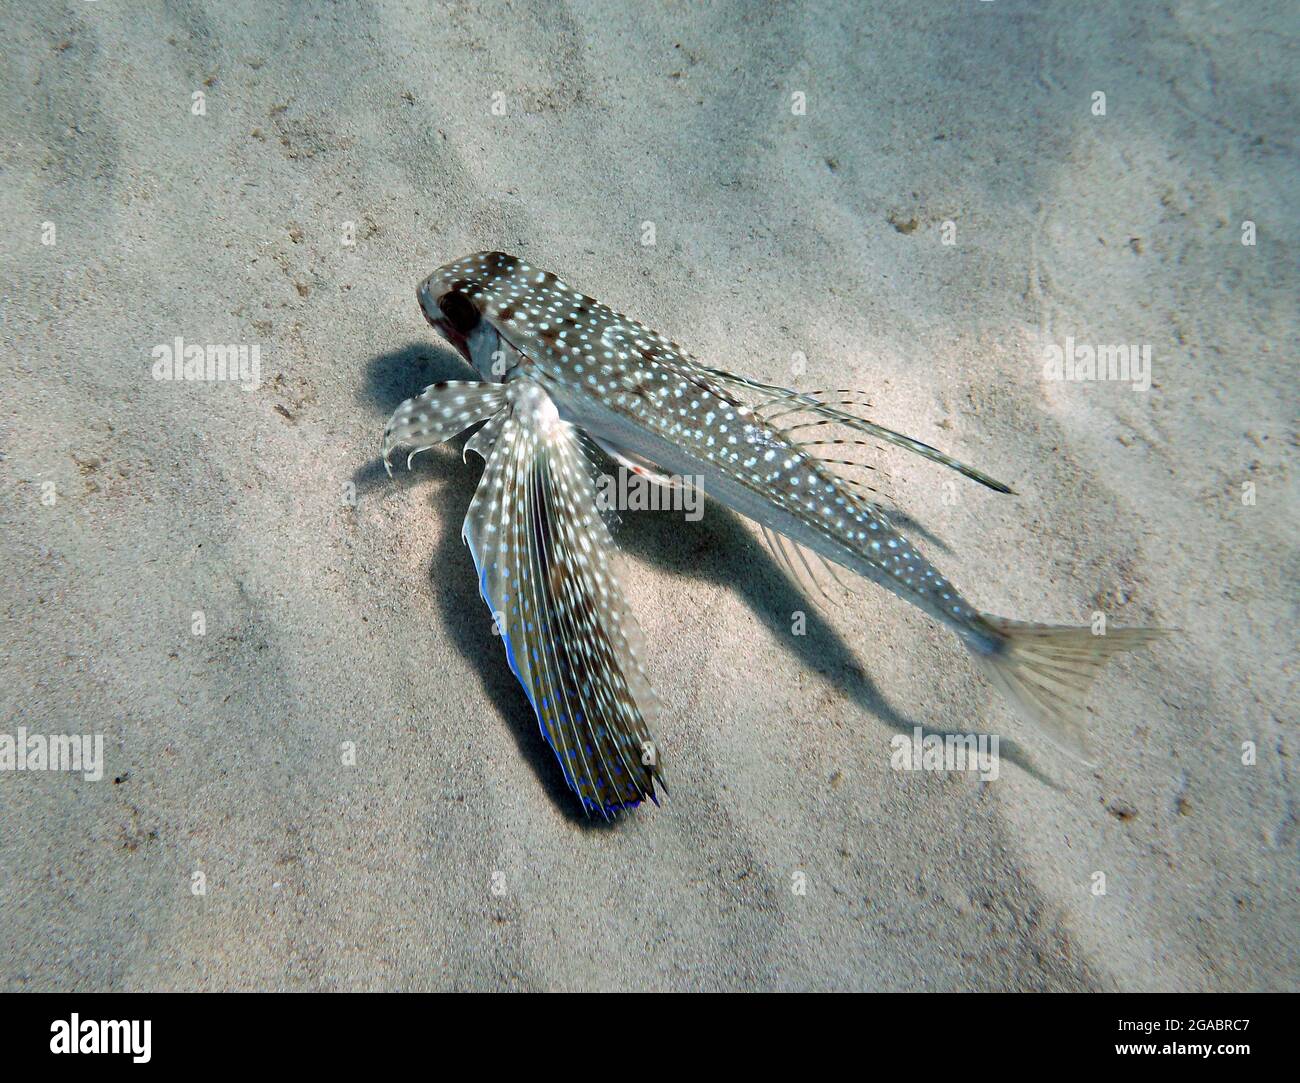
971,615,1164,763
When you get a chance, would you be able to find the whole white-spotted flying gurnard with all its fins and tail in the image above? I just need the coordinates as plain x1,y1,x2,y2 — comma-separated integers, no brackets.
384,252,1157,816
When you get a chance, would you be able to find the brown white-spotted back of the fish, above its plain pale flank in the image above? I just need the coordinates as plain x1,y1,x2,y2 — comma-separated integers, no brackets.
429,252,979,625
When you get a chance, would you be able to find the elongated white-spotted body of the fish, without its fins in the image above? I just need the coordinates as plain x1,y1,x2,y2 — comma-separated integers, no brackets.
420,252,1005,642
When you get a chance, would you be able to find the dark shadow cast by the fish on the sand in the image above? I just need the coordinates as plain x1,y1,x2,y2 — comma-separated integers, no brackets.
352,343,1056,829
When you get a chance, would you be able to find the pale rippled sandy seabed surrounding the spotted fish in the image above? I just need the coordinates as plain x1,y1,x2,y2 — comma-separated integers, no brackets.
0,0,1300,989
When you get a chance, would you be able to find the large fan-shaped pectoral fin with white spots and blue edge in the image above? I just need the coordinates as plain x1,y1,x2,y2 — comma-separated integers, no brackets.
464,380,663,816
